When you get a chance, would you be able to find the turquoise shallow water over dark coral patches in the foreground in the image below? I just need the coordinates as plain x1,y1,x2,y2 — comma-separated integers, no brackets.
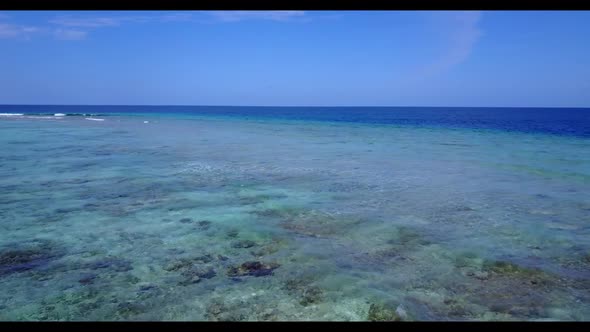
0,115,590,320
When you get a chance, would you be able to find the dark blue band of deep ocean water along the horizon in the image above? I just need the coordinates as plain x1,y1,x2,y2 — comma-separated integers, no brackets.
0,105,590,137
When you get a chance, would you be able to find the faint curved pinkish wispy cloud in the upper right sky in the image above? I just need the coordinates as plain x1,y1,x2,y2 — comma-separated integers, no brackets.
419,11,483,77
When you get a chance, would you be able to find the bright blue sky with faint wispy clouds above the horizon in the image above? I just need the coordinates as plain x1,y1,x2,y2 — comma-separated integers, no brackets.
0,11,590,107
